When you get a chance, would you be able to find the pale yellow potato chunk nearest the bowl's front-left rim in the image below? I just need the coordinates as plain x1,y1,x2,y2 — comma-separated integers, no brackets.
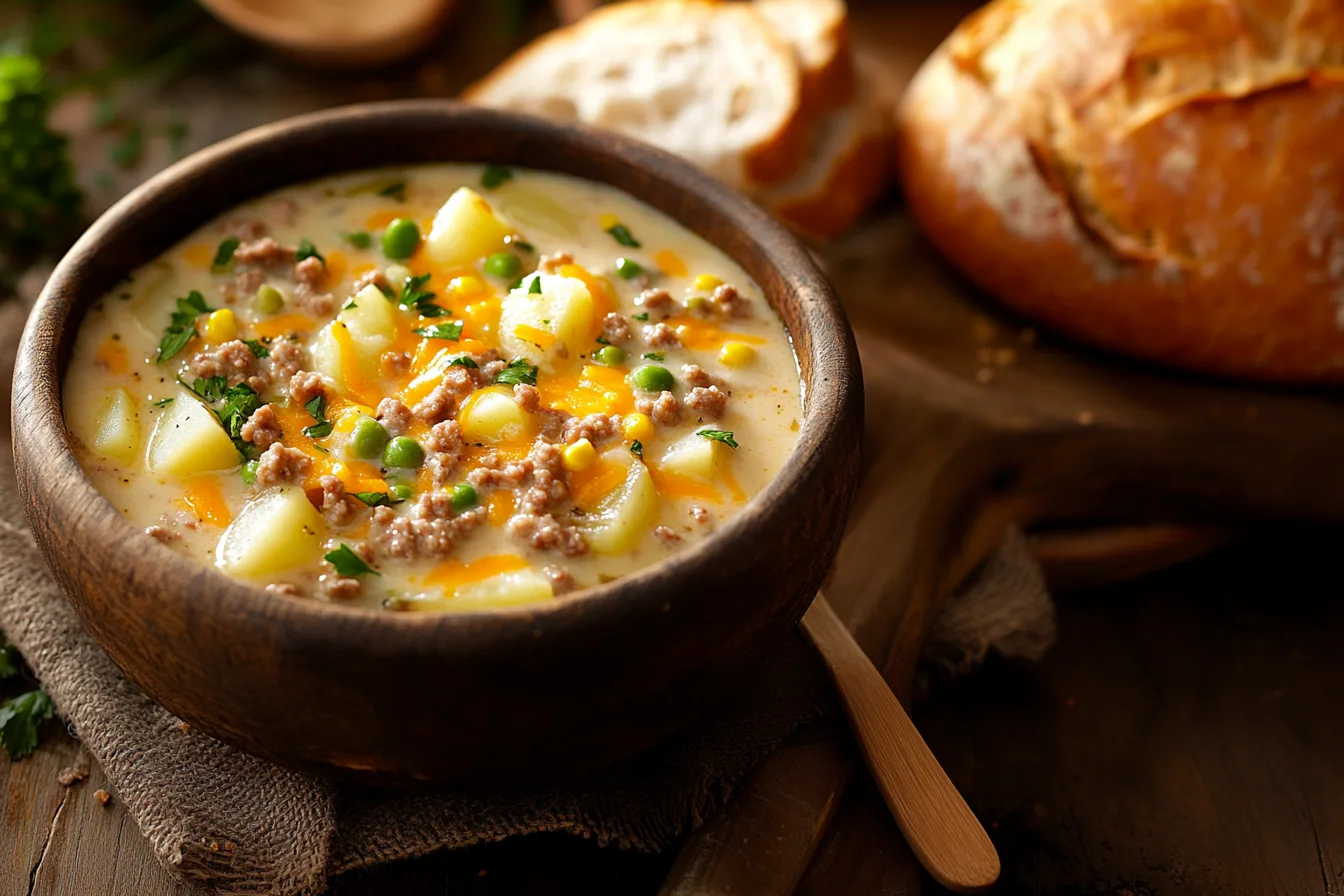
215,488,324,579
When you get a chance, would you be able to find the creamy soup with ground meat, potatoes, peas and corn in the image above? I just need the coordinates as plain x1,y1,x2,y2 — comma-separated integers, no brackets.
65,165,800,610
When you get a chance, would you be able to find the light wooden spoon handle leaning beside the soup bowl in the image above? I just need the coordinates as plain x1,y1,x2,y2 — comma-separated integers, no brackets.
802,594,999,893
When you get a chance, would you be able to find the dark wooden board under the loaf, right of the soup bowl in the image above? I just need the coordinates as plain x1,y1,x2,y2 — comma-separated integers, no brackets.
663,208,1344,896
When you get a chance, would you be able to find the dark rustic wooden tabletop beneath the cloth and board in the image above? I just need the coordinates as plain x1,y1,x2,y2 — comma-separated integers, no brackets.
0,1,1344,896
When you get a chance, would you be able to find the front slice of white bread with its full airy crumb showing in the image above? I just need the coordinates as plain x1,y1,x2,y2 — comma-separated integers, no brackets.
462,0,809,189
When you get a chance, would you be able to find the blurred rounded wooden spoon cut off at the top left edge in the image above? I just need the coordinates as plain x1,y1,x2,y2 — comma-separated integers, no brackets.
200,0,453,67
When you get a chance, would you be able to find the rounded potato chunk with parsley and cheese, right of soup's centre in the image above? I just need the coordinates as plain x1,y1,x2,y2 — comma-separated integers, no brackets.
499,274,598,371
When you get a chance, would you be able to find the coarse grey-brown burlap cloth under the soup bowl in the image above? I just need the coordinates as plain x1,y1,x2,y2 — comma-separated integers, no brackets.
0,301,1054,896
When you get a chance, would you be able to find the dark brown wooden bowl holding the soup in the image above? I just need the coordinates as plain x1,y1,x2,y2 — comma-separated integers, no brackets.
13,101,863,782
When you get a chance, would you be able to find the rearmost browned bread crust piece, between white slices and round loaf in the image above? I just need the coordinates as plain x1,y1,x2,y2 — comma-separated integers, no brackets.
754,59,892,240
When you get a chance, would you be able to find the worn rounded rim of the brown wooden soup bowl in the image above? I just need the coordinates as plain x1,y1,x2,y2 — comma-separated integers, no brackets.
13,99,862,647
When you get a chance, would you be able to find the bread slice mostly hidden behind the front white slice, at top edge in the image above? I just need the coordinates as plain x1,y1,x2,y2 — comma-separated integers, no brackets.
755,0,855,116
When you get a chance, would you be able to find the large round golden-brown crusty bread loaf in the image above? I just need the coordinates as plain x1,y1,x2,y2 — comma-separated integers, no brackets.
896,0,1344,383
